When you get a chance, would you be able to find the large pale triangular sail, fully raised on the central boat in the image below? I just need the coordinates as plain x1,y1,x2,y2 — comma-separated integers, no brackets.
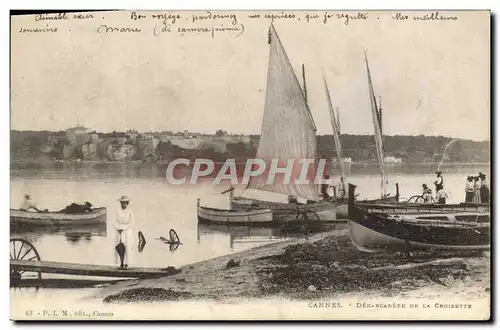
247,25,319,201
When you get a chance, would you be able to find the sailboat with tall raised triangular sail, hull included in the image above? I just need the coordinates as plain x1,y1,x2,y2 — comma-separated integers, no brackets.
231,24,338,222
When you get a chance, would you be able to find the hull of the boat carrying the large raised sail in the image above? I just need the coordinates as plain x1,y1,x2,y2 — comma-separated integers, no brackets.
231,198,340,222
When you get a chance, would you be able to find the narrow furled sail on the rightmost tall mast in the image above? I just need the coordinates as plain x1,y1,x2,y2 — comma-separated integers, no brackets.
365,52,387,197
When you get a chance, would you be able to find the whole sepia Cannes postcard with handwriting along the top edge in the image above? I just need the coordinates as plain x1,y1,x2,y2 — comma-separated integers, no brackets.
9,9,492,320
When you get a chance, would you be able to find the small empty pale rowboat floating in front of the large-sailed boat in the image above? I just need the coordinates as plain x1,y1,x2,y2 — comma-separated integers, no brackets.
197,198,273,225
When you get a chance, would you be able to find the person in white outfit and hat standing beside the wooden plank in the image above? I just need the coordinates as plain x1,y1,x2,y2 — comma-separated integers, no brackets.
115,196,134,268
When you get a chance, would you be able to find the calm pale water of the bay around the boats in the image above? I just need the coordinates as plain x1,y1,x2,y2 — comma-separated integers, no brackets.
10,164,490,302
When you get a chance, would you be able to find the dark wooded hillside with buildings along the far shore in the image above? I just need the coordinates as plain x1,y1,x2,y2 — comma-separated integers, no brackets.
10,131,491,163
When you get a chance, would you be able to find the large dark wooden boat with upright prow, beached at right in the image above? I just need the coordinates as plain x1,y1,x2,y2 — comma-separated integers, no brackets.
348,184,490,251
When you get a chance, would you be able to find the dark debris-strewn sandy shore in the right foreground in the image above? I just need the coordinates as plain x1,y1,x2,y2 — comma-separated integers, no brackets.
89,230,490,303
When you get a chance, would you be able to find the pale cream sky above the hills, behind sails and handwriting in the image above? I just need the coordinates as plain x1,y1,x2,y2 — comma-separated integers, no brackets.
11,11,490,141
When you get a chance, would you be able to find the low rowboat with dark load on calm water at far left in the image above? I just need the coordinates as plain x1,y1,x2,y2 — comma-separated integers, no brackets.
10,207,106,226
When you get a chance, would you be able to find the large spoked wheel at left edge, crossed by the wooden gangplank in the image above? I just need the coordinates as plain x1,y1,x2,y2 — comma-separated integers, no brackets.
10,238,42,281
